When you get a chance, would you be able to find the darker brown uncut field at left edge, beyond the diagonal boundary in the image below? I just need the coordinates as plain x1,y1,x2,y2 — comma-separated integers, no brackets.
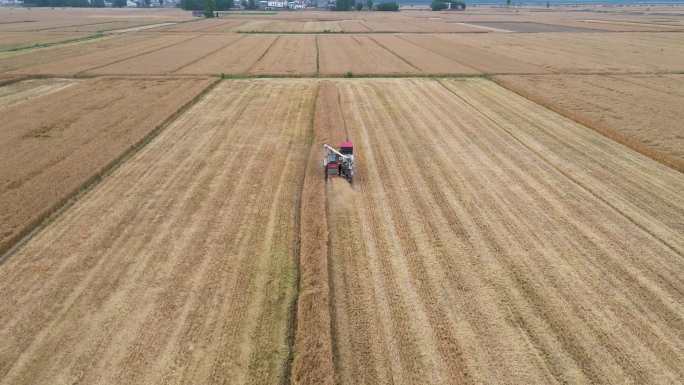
0,79,214,255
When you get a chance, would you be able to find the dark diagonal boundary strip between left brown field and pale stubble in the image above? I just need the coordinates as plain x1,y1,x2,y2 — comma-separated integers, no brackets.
0,78,221,266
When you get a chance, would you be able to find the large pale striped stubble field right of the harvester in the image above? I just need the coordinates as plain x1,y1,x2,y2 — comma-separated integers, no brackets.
327,79,684,384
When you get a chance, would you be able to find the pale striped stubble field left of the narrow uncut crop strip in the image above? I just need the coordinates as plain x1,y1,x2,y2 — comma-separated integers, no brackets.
0,80,316,385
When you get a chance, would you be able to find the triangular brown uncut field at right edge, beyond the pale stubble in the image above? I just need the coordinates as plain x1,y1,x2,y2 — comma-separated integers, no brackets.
496,75,684,172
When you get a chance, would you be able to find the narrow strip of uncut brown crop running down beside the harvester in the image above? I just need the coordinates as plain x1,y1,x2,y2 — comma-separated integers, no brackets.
292,81,338,385
